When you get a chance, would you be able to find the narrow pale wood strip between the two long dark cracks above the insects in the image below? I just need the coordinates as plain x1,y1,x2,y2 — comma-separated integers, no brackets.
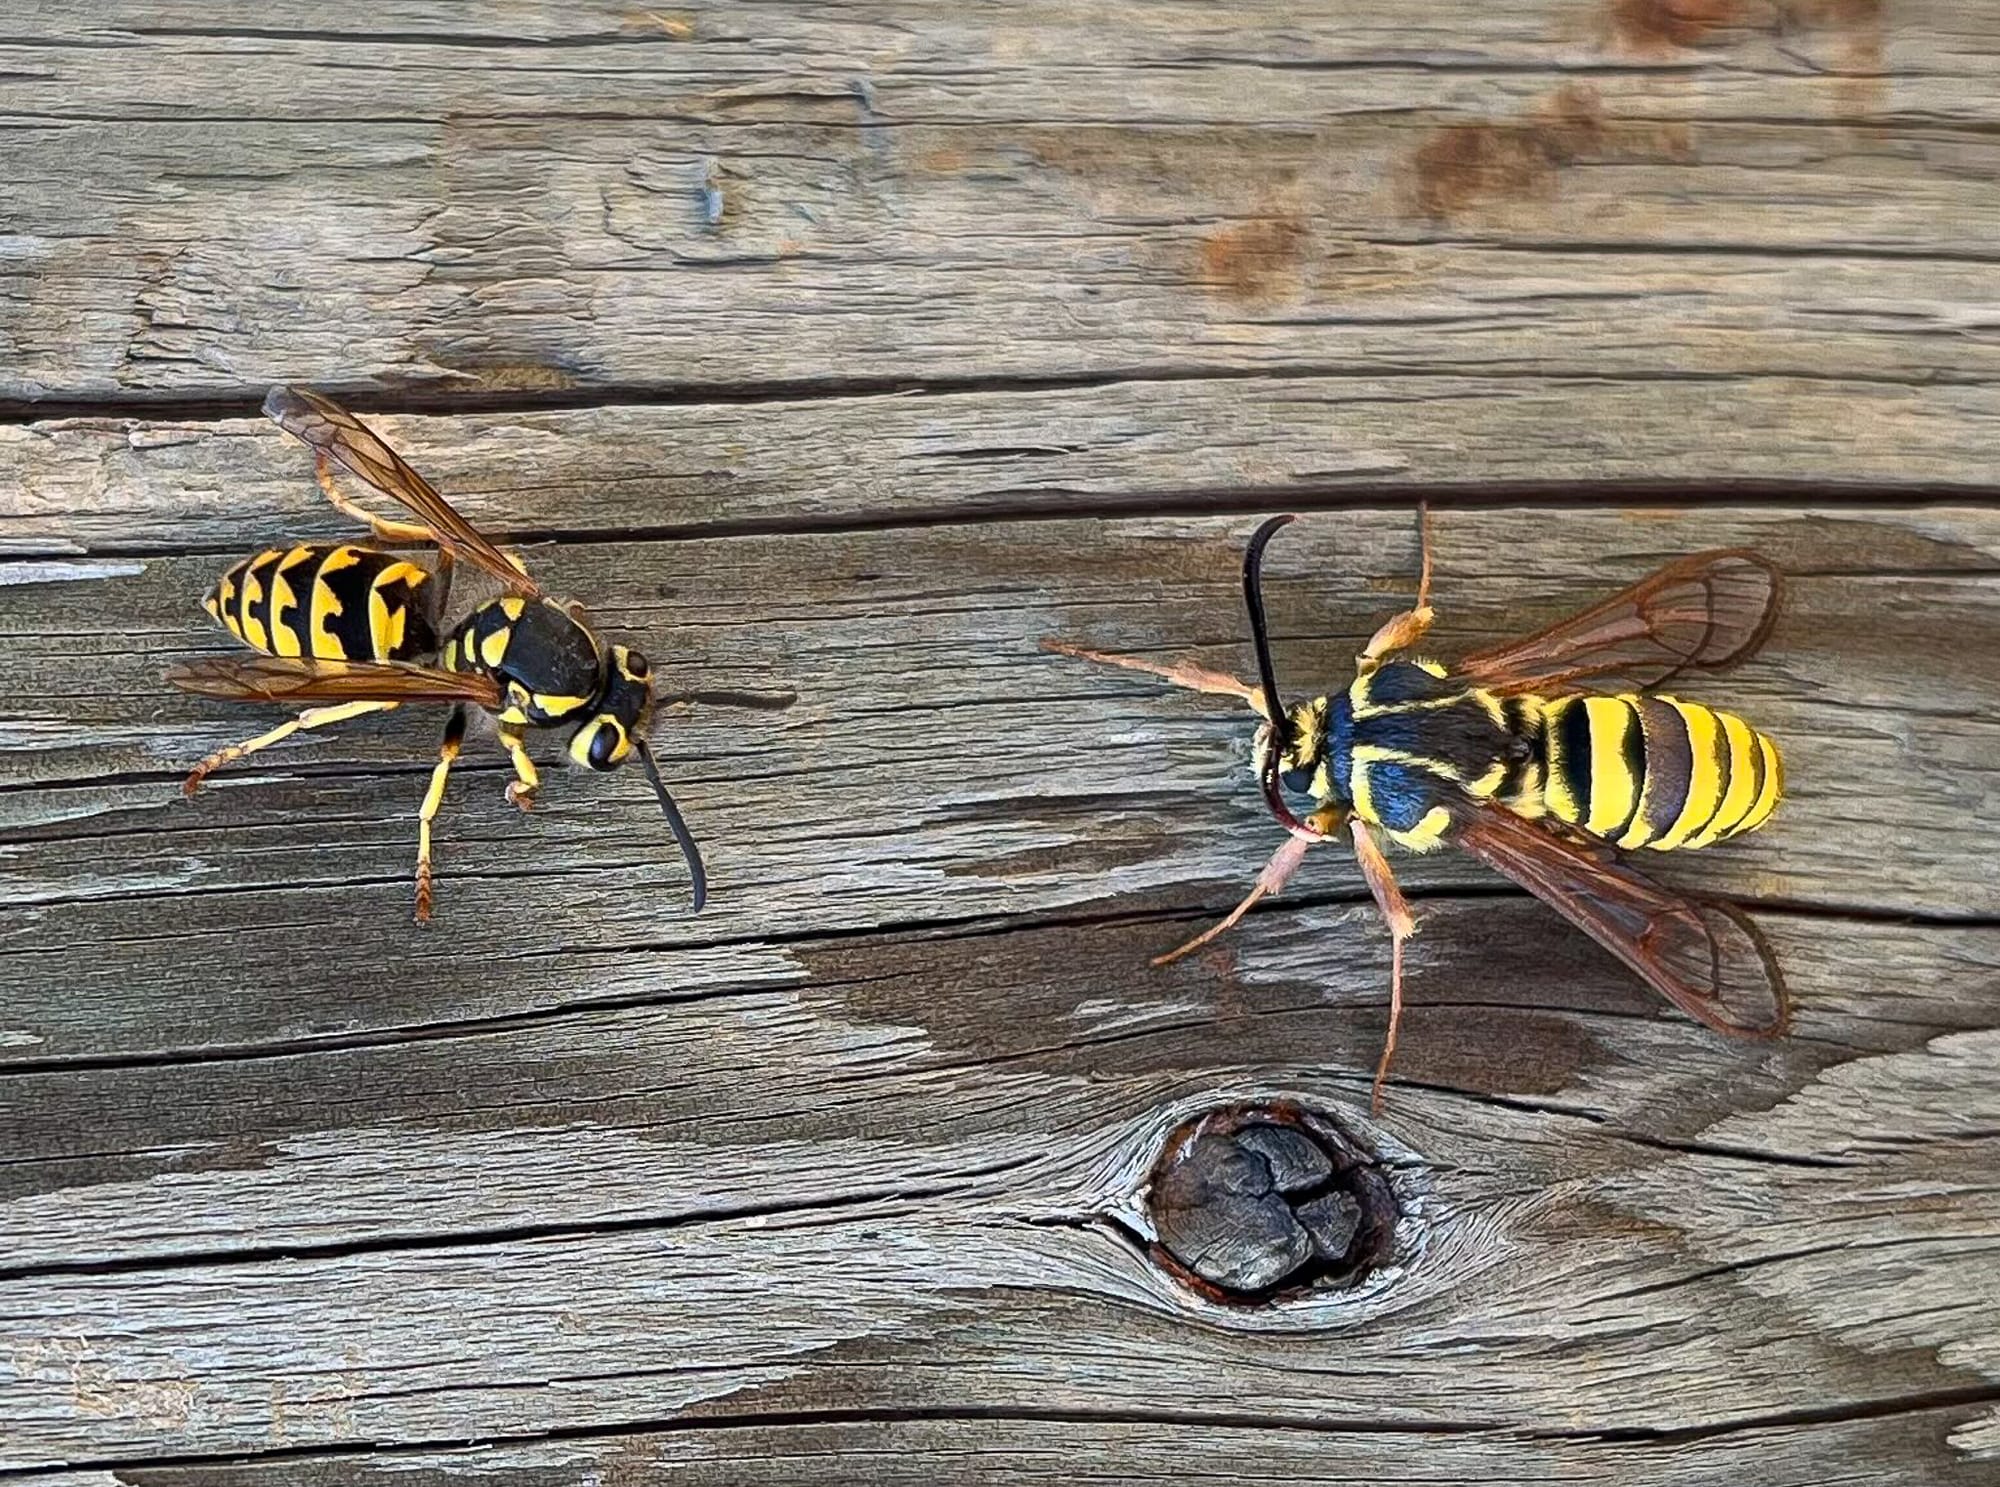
0,385,2000,572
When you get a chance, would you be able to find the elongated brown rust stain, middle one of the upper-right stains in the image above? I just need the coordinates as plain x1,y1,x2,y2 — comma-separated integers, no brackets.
1410,84,1690,222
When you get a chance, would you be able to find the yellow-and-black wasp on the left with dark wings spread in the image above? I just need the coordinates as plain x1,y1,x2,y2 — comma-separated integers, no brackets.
168,388,708,921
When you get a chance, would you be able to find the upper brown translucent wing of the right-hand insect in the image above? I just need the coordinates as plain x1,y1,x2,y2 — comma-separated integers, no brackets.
1452,548,1780,692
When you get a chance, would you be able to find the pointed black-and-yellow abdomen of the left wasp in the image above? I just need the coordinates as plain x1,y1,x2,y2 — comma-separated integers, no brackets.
202,546,438,662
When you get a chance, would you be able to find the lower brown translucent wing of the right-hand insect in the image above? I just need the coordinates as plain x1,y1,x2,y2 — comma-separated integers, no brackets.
1454,803,1790,1037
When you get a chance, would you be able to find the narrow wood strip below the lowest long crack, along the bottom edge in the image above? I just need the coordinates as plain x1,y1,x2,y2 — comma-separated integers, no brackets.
15,1405,1990,1487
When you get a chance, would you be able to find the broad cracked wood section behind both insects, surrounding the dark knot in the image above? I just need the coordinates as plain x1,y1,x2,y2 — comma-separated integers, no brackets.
0,508,2000,1471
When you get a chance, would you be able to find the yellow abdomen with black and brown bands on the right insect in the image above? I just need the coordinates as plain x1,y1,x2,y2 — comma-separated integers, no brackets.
1542,694,1784,851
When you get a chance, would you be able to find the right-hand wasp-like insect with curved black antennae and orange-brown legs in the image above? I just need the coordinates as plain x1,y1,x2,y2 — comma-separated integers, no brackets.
1046,516,1790,1109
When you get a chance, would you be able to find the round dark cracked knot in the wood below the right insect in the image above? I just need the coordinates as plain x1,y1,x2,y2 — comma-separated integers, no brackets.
1144,1101,1396,1303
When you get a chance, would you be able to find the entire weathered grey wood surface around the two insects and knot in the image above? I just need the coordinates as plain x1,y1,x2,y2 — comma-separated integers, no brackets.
0,0,2000,1487
